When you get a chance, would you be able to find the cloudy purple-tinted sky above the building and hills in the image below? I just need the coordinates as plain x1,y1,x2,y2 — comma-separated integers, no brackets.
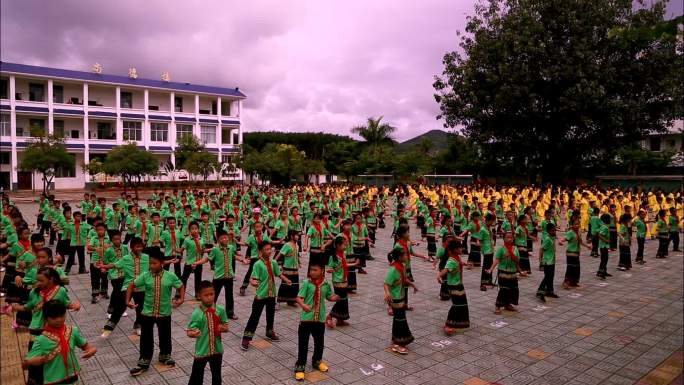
0,0,682,140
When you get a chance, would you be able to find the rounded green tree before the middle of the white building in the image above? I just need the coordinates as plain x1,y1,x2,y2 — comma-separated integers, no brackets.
102,143,159,197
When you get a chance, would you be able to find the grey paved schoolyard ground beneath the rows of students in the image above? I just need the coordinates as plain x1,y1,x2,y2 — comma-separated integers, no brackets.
2,196,684,385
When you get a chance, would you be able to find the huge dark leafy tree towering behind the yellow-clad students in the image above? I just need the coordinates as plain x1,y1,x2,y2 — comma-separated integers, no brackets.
434,0,683,181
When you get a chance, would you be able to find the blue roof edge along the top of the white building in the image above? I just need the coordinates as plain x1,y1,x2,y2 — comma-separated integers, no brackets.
0,61,246,98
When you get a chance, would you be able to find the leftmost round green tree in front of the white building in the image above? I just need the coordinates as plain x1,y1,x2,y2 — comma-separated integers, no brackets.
19,131,75,193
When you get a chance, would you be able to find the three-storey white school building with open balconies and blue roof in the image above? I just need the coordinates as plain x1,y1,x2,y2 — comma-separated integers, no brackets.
0,62,246,189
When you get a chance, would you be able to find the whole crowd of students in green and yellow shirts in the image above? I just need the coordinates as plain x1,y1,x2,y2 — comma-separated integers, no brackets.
0,185,682,384
